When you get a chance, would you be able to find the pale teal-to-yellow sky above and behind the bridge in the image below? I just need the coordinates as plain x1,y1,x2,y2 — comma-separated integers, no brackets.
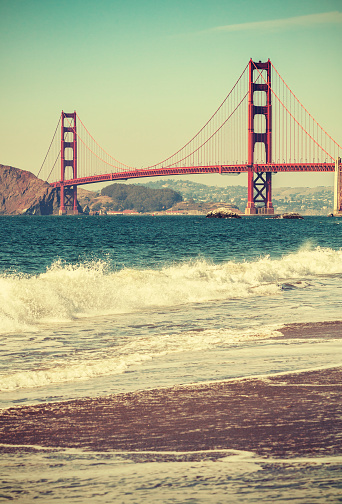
0,0,342,188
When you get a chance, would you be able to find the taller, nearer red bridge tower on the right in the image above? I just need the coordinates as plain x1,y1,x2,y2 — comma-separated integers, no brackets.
245,59,274,215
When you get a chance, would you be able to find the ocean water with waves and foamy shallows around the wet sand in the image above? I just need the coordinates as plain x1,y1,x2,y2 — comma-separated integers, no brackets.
0,216,342,504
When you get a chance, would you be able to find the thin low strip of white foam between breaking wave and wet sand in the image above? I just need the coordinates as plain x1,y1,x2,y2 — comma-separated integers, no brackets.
0,326,279,392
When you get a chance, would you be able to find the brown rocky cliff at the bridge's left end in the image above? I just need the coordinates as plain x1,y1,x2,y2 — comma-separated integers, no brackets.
0,165,59,215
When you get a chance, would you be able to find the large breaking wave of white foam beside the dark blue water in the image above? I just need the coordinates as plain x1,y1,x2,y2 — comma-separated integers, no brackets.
0,247,342,334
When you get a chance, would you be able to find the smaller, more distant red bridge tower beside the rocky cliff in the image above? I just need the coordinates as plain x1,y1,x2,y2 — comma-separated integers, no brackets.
59,111,78,215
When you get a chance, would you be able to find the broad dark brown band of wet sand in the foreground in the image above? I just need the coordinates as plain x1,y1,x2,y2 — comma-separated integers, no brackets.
0,367,342,457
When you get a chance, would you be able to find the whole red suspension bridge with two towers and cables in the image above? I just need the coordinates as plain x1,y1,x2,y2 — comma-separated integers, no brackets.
38,59,342,214
